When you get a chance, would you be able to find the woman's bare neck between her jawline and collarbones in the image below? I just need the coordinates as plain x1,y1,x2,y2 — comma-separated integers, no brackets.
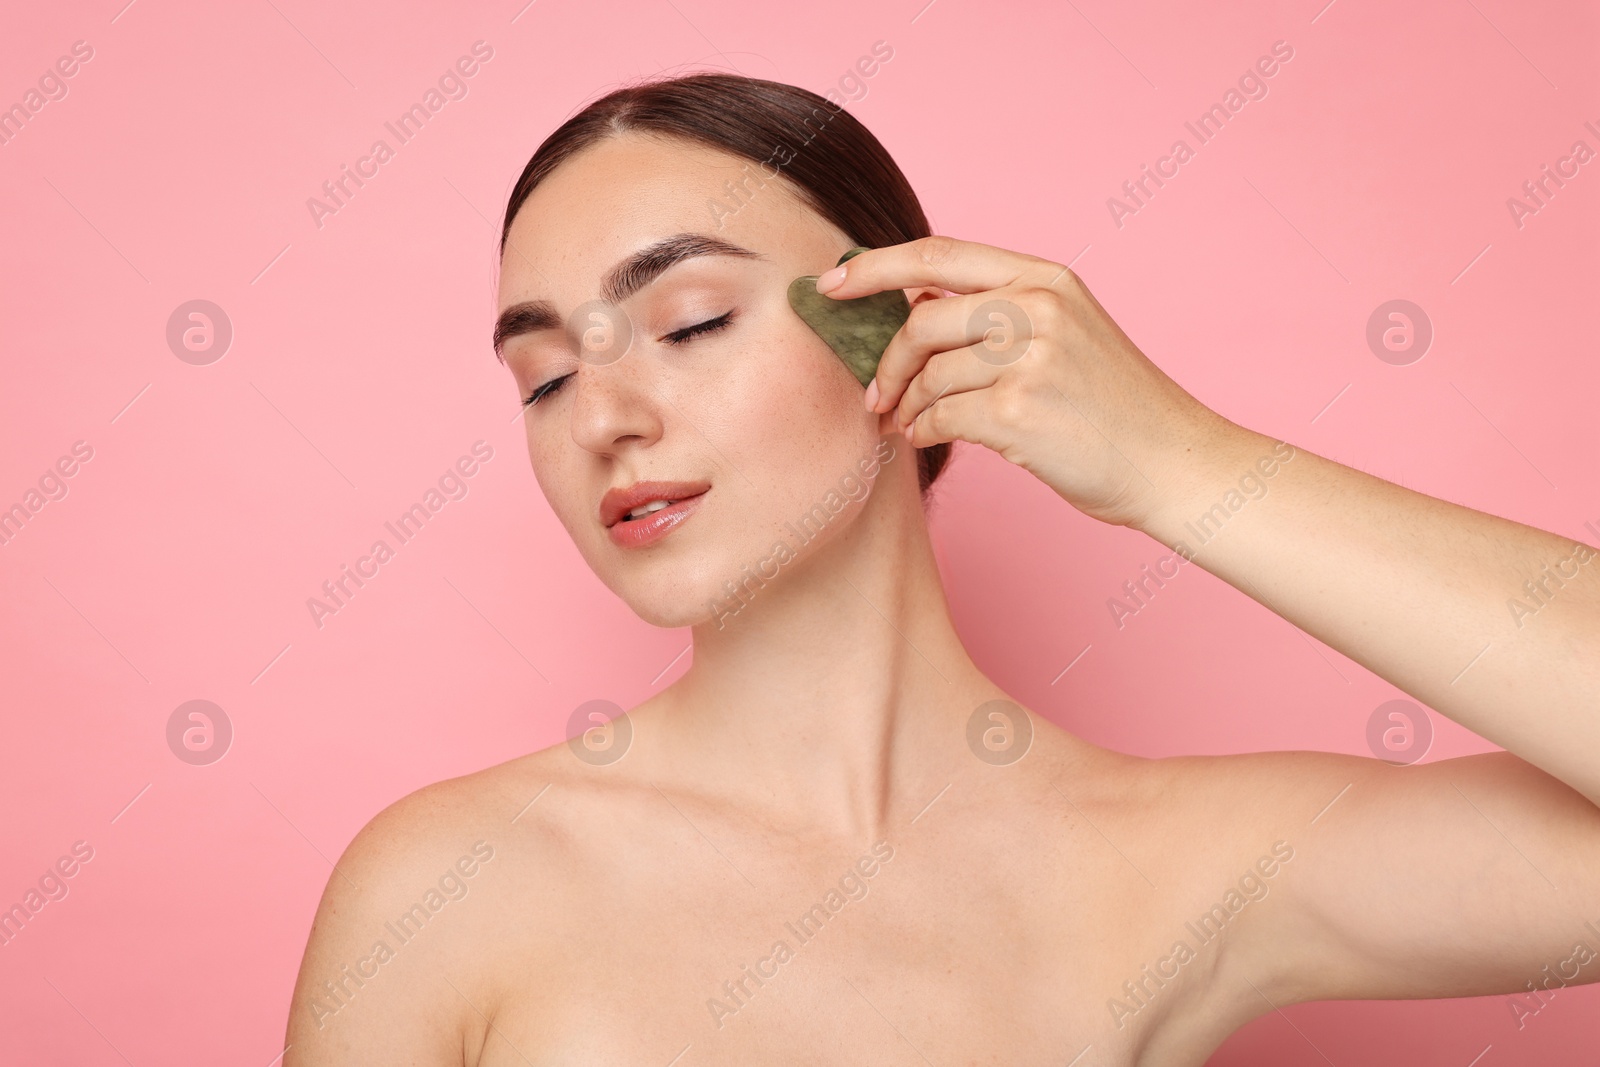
643,460,1000,838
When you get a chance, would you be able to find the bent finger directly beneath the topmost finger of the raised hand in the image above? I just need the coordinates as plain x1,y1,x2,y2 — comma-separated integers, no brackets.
872,290,1032,411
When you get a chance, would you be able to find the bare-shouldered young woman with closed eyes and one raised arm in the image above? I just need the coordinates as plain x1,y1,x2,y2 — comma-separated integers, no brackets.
285,74,1600,1067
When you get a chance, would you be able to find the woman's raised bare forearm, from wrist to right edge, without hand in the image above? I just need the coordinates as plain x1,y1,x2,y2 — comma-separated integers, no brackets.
1139,424,1600,803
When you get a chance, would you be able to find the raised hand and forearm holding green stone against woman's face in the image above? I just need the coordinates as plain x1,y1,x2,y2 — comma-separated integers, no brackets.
818,237,1600,805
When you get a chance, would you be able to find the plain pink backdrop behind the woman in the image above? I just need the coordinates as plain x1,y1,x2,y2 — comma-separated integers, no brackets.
0,0,1600,1067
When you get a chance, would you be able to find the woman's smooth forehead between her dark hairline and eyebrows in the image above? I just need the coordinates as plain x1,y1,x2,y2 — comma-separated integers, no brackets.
499,133,848,309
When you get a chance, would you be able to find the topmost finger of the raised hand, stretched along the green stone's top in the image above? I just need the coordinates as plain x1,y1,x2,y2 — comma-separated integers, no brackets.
816,235,1059,299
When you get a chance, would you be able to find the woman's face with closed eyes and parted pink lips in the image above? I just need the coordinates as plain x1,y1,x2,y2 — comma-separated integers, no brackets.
499,134,917,625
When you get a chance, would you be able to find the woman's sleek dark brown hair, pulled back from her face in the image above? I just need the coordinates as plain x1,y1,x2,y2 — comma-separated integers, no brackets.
501,72,950,494
